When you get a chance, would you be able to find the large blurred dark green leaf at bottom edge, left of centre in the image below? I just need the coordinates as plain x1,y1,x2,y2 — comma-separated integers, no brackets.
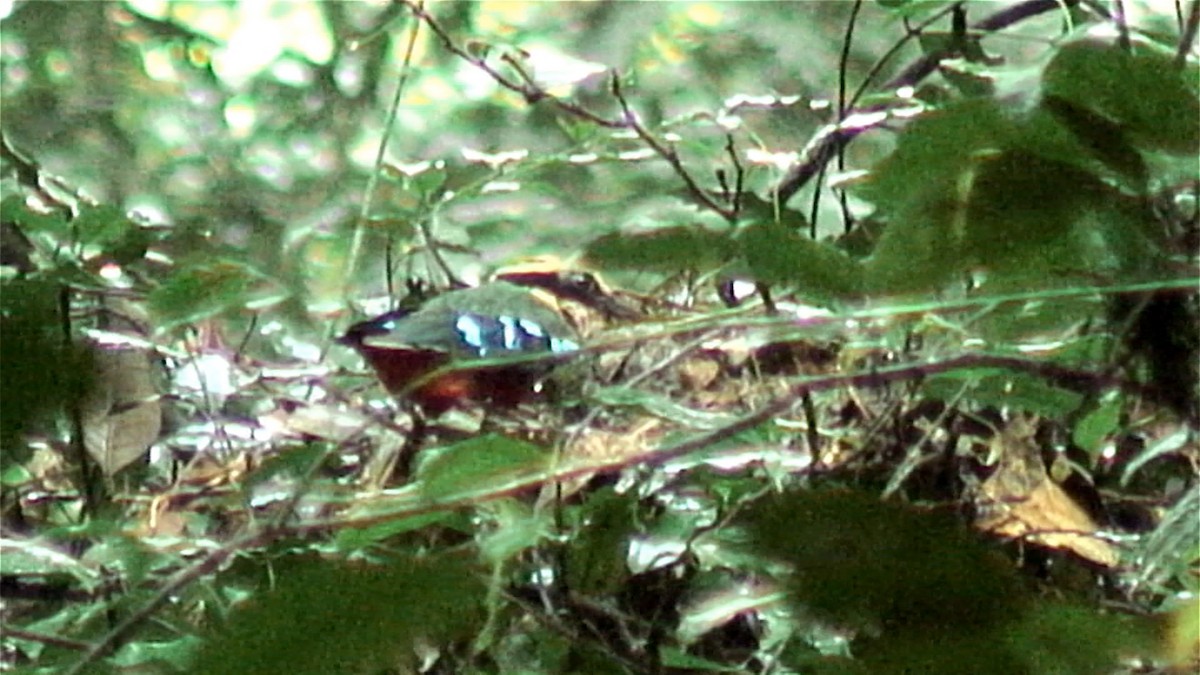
188,555,485,675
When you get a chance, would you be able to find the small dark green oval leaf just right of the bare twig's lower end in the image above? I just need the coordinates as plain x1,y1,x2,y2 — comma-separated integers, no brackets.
738,222,863,300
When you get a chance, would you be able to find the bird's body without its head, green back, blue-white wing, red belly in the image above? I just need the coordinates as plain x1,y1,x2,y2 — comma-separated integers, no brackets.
337,281,581,416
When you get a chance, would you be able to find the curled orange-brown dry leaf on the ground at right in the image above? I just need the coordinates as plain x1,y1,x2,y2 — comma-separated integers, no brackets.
976,418,1118,567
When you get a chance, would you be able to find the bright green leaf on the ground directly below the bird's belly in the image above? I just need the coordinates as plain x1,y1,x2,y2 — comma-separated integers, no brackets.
416,434,551,501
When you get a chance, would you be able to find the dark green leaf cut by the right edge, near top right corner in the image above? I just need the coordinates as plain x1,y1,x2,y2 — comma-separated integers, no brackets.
1042,38,1200,155
